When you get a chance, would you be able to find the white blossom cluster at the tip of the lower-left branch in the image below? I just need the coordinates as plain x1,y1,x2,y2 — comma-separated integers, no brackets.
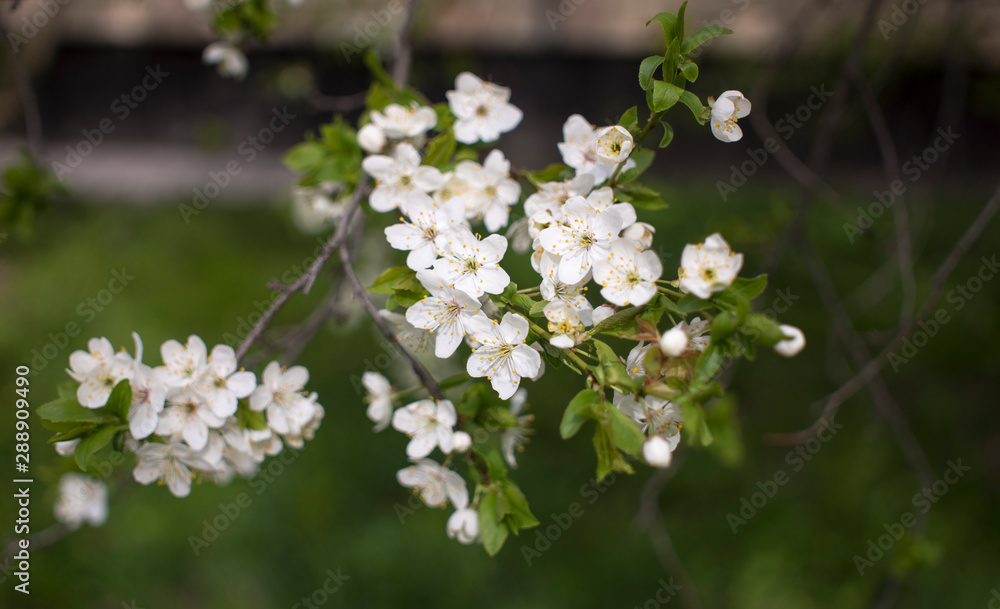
48,333,324,498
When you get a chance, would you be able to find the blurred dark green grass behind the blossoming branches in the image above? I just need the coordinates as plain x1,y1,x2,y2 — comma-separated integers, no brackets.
0,177,1000,609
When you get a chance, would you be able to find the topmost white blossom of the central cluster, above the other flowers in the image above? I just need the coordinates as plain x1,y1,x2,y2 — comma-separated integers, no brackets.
445,72,523,144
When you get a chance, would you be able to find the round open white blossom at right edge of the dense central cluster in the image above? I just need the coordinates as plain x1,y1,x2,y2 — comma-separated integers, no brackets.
594,239,663,306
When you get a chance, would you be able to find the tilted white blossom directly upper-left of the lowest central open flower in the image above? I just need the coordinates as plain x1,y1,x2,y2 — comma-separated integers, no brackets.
406,271,488,359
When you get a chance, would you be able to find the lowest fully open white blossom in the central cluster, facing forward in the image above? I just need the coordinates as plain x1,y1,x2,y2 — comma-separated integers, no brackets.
466,313,542,400
